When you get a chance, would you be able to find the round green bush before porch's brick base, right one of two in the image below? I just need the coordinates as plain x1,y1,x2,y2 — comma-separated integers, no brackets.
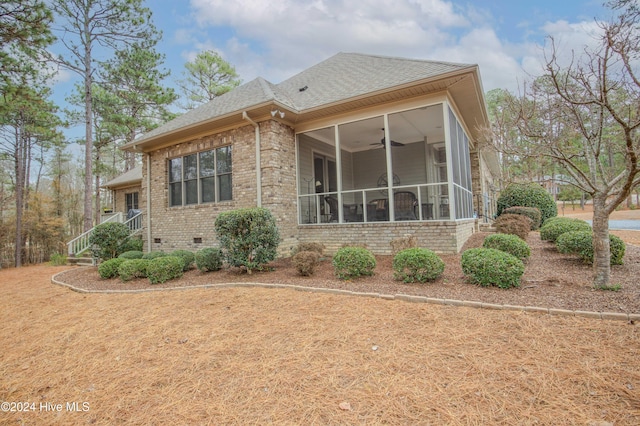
393,246,444,283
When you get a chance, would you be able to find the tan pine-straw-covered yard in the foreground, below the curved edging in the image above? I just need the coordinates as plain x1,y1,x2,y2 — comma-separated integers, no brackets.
0,226,640,426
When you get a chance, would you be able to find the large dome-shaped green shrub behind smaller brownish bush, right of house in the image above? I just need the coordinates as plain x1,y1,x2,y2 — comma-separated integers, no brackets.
497,183,558,224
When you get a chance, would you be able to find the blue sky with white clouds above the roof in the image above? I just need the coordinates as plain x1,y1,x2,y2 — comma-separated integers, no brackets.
48,0,610,141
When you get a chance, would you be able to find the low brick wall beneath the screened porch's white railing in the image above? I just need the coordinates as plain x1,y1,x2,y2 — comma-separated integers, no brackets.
299,220,475,254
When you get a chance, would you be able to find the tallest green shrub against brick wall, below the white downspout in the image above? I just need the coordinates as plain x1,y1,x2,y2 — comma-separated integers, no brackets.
215,207,280,273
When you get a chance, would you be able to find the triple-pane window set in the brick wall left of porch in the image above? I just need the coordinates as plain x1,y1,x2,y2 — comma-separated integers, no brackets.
168,146,232,207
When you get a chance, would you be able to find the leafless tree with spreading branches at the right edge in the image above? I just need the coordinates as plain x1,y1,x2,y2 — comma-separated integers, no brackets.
518,0,640,287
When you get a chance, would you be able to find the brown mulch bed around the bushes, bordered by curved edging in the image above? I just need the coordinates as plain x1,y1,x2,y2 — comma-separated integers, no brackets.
60,232,640,314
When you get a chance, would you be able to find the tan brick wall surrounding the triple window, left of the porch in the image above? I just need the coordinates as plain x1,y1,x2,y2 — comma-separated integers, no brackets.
140,121,297,255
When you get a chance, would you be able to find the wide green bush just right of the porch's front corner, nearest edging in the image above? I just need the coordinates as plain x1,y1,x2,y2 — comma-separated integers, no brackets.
461,248,524,288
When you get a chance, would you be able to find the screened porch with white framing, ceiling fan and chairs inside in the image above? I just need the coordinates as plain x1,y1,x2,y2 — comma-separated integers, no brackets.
296,99,474,226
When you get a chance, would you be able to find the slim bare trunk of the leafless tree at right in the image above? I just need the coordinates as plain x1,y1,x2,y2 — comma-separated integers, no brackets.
593,197,611,287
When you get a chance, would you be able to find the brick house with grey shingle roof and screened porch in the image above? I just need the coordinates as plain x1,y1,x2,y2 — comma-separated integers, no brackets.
119,53,499,254
